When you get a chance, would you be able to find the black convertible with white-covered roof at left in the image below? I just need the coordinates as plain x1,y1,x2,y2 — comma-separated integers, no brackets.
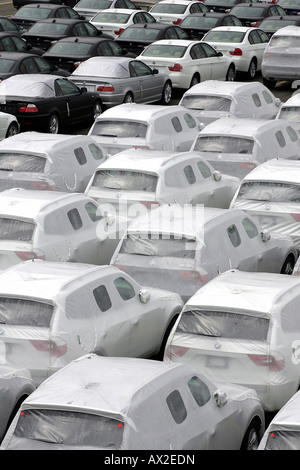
0,74,101,134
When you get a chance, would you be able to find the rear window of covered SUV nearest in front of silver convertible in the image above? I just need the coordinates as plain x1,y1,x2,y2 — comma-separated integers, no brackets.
92,119,148,138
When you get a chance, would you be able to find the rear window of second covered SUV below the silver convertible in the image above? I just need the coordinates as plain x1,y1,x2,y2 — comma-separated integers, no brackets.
92,170,157,192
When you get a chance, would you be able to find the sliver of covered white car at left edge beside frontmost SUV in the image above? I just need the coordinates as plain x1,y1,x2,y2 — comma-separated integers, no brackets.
0,366,36,442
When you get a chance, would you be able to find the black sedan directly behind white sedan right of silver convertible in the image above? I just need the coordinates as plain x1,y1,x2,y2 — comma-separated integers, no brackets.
115,22,188,56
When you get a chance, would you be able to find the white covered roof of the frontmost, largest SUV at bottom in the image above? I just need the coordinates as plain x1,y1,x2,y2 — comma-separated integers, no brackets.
23,354,191,421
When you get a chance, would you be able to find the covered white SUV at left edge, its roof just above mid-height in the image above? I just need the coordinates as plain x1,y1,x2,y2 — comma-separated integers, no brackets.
0,188,126,270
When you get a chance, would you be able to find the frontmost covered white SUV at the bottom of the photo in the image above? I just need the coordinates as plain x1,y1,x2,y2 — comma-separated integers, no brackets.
1,354,265,450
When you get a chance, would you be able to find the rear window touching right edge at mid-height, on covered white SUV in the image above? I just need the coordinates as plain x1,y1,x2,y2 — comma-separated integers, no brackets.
237,181,300,203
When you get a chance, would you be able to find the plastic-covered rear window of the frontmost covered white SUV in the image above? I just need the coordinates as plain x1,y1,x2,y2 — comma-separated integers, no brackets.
14,408,125,450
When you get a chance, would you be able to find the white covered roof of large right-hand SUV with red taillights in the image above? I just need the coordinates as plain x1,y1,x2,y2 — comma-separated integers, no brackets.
185,269,300,315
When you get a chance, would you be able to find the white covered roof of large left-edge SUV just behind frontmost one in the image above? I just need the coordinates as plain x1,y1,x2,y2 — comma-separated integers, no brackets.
0,259,119,303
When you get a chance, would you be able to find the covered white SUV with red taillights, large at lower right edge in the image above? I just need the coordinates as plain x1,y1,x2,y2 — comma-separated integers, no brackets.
164,270,300,412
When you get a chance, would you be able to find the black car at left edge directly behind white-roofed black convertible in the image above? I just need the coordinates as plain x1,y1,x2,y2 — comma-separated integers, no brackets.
0,52,70,80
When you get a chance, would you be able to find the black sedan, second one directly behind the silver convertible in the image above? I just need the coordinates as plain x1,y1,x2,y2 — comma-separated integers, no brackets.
22,18,113,51
